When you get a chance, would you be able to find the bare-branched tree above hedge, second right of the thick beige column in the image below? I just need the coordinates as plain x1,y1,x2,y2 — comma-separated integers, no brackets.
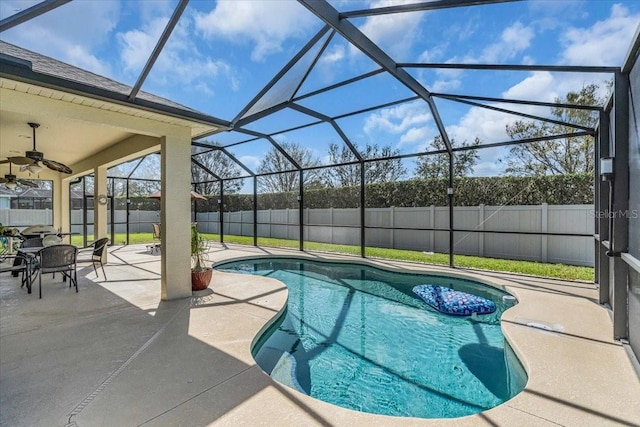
258,142,321,193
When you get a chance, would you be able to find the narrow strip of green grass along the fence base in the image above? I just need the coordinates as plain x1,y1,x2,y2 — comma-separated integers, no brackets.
81,233,594,282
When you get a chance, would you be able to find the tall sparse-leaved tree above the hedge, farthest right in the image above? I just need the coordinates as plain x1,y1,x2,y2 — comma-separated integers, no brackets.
500,83,611,175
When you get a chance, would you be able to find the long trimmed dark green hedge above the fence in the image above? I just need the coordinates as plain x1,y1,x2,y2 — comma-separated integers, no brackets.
116,174,593,212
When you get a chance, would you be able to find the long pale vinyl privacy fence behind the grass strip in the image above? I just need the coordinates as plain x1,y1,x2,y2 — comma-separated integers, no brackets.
0,204,594,266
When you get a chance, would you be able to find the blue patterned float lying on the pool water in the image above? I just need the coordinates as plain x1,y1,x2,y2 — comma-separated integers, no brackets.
413,285,496,316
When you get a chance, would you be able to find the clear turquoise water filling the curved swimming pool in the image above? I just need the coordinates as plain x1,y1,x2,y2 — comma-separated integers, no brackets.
216,259,527,418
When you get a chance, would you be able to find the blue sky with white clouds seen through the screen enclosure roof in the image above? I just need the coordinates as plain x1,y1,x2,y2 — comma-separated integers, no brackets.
0,0,640,181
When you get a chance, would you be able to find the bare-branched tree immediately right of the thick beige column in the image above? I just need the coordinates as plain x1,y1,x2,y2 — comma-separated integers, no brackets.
191,145,244,195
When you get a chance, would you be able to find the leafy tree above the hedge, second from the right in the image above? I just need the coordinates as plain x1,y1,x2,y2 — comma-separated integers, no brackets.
416,136,481,179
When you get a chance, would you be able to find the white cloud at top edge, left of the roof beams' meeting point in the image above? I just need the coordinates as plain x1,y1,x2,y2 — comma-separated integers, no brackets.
195,0,318,61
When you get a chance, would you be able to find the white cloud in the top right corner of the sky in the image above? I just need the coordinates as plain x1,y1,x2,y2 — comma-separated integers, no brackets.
561,4,640,66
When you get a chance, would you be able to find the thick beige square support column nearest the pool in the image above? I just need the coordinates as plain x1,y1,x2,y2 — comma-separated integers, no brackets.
160,128,191,301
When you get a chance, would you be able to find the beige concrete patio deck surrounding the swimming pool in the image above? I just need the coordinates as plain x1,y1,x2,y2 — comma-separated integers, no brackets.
0,244,640,427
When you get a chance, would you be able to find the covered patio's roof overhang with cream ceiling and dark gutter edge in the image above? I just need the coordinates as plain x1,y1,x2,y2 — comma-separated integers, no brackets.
0,43,229,179
